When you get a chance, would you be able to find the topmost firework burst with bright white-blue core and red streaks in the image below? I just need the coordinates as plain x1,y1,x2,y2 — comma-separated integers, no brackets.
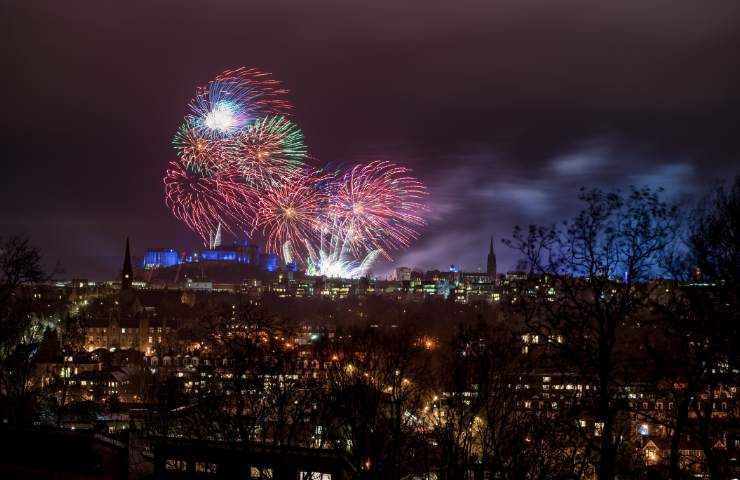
189,67,292,139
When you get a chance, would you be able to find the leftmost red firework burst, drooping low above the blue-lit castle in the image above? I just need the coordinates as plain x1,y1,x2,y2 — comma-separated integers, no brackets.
164,162,255,245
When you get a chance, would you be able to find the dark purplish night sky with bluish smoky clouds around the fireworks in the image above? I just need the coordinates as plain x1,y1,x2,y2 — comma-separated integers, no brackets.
0,0,740,279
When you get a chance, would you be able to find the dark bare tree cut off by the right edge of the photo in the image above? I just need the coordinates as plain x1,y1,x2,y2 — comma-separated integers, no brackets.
656,176,740,479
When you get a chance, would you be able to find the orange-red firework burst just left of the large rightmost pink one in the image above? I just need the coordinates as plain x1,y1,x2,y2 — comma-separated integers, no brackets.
256,170,328,258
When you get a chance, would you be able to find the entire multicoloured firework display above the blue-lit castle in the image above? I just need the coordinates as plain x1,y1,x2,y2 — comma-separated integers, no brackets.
164,68,426,268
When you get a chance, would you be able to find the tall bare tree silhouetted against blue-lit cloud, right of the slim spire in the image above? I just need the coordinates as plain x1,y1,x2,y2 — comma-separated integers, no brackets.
507,187,676,480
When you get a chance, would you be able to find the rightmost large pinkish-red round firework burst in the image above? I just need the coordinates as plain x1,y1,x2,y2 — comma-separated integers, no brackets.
329,161,427,260
